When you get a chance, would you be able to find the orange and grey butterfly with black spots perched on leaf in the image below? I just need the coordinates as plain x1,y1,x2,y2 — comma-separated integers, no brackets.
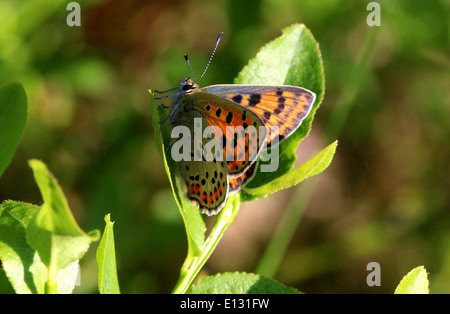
155,33,316,216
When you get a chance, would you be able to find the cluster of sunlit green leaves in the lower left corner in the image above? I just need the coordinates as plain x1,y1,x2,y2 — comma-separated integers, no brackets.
0,160,99,293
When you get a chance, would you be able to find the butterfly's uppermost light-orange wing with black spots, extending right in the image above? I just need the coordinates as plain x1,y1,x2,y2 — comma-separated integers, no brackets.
199,85,316,145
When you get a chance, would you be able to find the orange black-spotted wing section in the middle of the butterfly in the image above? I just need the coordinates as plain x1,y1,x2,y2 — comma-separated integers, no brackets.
187,92,267,176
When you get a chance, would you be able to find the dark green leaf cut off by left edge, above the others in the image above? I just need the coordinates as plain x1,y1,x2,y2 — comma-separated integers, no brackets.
0,82,28,176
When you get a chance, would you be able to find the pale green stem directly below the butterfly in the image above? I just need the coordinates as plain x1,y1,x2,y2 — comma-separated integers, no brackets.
172,194,239,294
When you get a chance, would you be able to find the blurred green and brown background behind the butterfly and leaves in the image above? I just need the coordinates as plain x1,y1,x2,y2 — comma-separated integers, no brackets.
0,0,450,293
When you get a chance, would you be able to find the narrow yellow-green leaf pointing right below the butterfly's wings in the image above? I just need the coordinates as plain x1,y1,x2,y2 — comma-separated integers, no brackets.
245,141,337,195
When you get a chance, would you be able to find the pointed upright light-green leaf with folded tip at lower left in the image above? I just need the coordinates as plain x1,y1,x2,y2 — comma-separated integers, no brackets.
26,160,99,293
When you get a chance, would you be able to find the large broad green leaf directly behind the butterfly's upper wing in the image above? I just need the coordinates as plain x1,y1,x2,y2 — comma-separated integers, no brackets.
235,24,325,190
